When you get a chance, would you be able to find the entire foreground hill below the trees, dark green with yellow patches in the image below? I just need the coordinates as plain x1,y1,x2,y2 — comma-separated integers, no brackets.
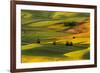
22,44,89,63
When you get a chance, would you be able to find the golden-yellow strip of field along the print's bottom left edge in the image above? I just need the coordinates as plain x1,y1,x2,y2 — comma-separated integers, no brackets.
22,55,67,63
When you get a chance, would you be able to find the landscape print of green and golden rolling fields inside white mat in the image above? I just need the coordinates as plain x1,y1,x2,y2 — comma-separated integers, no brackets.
21,10,90,63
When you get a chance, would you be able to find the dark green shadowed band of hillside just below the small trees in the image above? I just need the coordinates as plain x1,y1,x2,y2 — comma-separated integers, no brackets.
21,44,89,57
